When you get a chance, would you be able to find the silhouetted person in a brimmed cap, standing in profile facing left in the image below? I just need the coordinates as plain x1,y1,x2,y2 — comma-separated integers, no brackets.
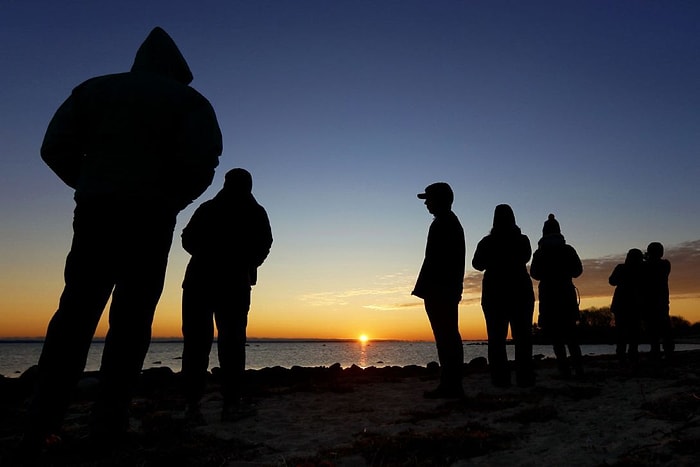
411,182,466,399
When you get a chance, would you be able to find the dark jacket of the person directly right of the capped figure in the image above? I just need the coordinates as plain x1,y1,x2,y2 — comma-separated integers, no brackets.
472,227,535,312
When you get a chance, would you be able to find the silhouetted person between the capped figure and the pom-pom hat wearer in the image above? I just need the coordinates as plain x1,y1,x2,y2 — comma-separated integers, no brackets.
472,204,535,387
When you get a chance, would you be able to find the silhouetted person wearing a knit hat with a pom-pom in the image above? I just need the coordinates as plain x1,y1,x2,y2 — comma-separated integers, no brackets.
530,214,583,378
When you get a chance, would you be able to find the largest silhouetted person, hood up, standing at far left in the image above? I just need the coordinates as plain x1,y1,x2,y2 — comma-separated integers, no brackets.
23,28,222,449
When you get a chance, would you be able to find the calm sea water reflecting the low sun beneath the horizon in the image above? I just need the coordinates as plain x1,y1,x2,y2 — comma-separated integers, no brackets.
0,341,700,377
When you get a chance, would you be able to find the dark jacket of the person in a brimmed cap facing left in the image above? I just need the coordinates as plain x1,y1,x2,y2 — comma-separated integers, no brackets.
411,211,466,301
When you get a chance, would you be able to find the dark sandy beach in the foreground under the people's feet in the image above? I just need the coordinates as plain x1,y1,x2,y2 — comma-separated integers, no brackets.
0,351,700,466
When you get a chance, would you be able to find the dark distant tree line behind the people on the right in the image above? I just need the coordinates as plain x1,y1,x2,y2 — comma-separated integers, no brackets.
532,306,700,344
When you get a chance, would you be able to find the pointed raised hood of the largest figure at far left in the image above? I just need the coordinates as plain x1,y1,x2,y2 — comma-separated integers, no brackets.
131,27,194,85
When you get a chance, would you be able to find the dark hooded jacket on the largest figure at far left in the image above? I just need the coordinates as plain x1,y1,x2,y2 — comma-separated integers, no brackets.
41,28,222,211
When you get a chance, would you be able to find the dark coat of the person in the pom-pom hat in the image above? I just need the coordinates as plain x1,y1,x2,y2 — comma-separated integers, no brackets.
530,234,583,324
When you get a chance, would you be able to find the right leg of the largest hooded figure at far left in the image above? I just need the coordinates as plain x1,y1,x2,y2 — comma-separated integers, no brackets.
93,206,175,432
